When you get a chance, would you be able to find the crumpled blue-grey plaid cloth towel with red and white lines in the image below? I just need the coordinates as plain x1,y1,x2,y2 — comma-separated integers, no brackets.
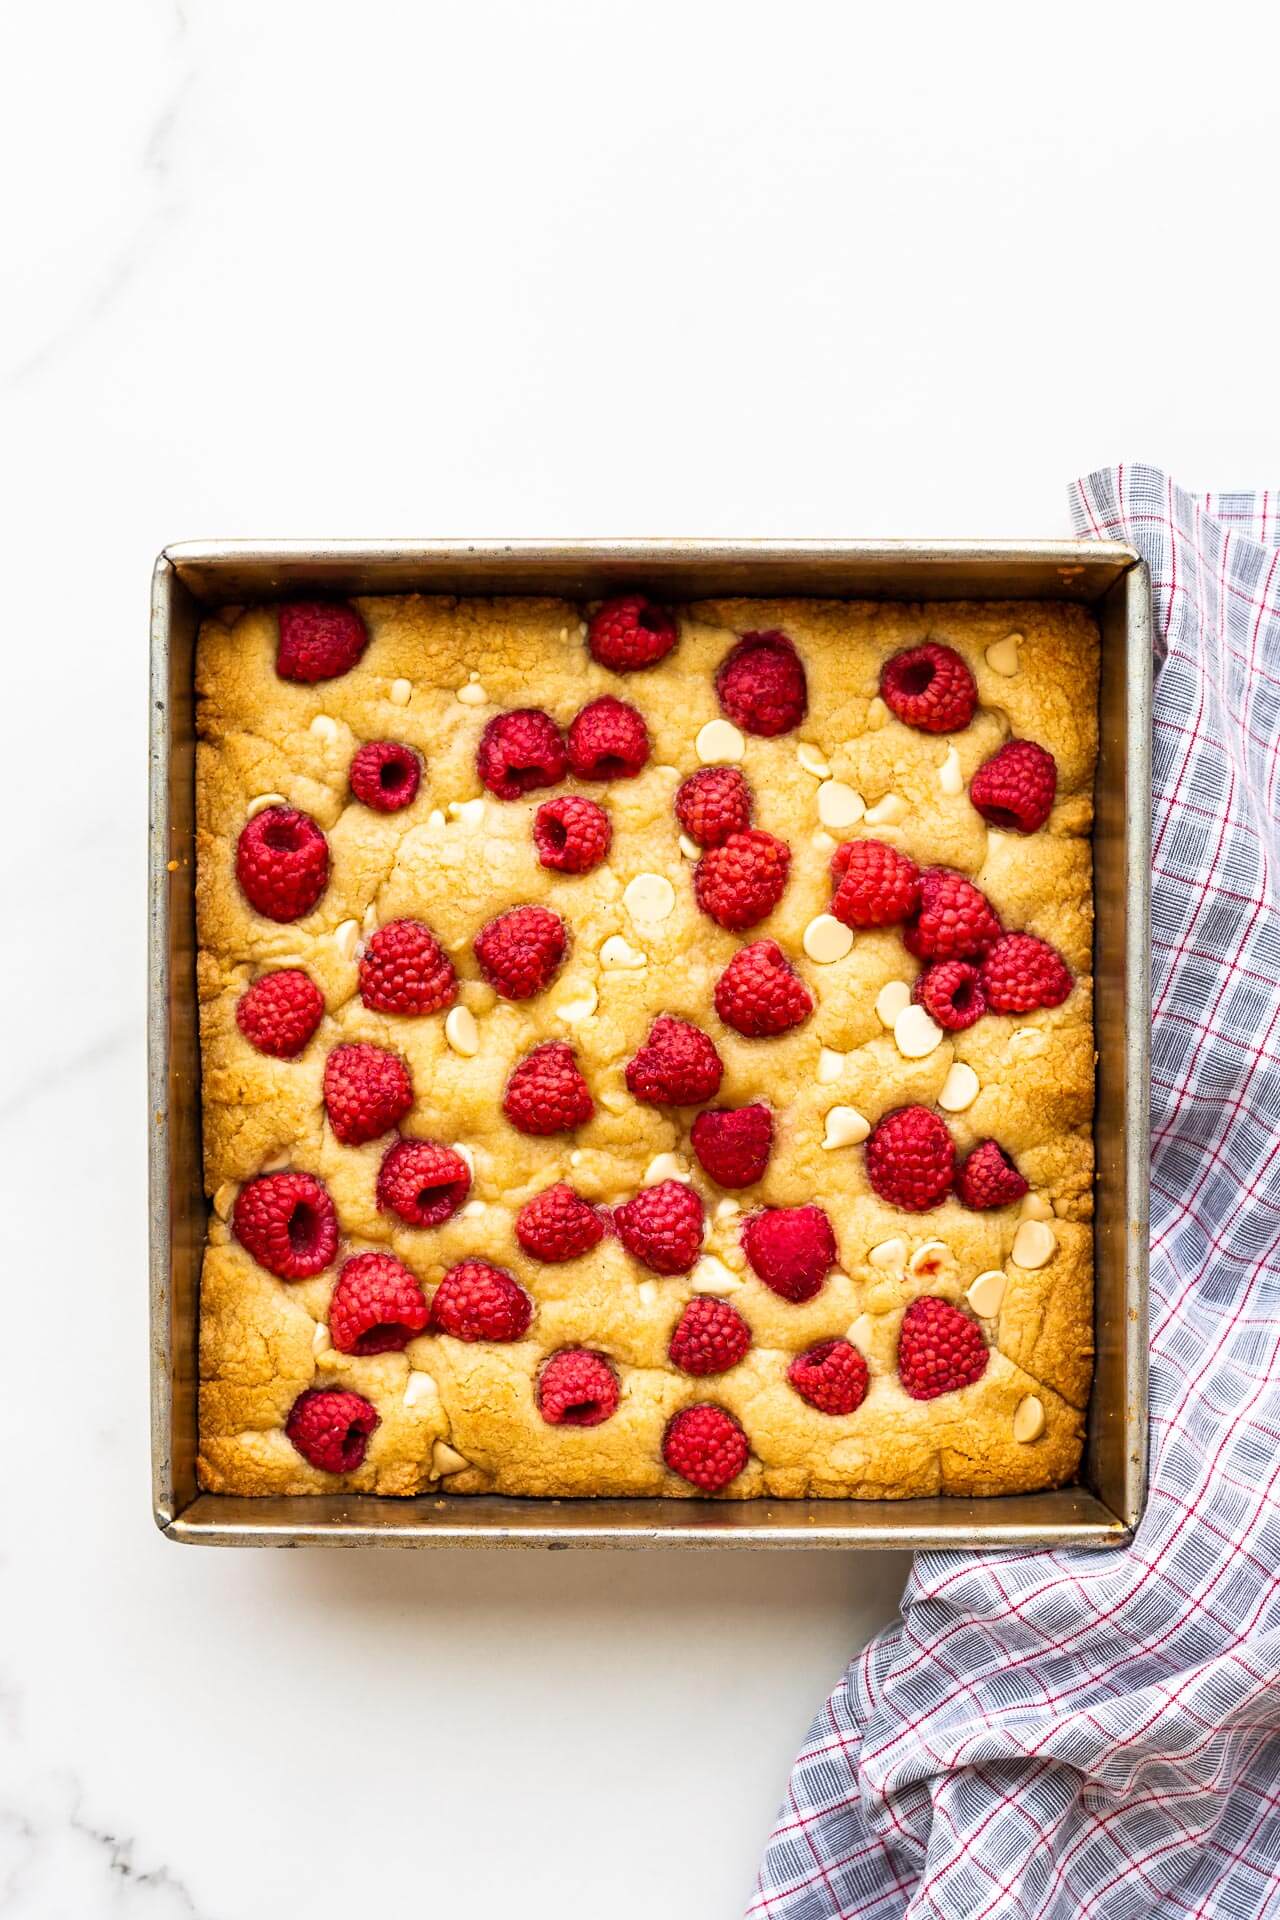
748,467,1280,1920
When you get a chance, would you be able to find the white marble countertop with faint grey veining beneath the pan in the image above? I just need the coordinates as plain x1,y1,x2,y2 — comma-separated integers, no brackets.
0,0,1280,1920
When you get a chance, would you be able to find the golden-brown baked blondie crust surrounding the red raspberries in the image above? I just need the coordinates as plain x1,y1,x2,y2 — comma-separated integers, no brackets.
198,597,1098,1498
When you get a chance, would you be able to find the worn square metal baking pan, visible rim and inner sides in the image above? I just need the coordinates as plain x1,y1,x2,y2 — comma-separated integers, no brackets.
148,540,1151,1548
